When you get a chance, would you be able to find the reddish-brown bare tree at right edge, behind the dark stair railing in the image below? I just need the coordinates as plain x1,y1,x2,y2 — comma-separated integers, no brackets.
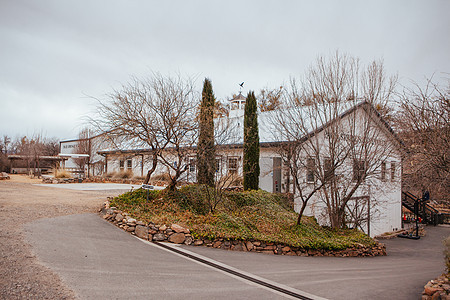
395,78,450,201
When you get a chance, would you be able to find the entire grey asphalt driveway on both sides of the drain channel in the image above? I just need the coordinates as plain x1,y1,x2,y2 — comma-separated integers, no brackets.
26,214,450,299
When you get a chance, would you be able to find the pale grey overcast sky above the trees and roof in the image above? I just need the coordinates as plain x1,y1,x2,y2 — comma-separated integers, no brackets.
0,0,450,139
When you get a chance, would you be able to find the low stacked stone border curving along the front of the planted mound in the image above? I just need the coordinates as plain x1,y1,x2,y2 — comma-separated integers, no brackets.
99,201,386,257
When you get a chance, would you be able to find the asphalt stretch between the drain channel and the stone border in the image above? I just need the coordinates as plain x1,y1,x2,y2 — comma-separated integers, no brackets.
183,226,450,299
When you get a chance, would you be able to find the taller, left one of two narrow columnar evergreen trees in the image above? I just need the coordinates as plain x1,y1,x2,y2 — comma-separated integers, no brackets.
197,78,216,186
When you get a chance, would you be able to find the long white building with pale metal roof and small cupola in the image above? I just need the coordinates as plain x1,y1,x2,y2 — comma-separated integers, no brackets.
88,94,402,236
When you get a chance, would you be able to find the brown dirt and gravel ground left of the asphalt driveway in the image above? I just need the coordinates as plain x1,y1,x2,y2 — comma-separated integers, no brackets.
0,175,123,299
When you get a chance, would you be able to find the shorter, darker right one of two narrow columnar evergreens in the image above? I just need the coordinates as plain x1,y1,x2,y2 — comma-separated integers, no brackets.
244,91,259,190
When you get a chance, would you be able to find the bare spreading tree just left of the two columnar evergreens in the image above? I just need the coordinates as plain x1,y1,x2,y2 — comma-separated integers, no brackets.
91,73,198,189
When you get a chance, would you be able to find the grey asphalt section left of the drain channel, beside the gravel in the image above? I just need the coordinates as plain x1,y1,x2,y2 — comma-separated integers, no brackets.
26,214,306,299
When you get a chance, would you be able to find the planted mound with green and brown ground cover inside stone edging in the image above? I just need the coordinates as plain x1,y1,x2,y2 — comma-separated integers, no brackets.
110,185,376,250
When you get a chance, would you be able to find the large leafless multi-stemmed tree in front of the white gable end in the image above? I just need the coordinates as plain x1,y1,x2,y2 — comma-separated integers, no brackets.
272,52,396,228
